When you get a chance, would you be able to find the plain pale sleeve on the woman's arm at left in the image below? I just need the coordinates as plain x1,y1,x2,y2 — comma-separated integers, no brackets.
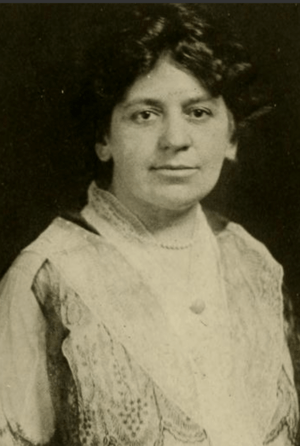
0,255,55,446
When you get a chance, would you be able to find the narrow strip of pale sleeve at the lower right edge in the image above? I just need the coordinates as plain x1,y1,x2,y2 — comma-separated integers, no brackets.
263,343,299,446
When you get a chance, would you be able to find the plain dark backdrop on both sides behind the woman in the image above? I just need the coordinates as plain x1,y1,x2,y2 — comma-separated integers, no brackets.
0,3,300,315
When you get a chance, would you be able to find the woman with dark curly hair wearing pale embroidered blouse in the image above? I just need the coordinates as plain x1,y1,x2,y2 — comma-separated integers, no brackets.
0,4,298,446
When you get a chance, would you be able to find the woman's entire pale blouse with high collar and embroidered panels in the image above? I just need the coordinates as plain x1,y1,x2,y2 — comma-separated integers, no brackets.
0,184,298,446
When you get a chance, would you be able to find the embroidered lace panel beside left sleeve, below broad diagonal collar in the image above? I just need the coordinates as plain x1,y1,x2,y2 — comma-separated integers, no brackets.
33,262,206,446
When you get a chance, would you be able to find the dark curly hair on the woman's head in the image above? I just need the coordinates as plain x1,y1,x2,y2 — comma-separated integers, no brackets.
74,3,268,185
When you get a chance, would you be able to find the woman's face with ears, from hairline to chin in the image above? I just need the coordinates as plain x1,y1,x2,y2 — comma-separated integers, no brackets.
96,57,235,215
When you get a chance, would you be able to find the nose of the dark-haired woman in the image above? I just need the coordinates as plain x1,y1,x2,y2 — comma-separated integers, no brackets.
160,115,191,151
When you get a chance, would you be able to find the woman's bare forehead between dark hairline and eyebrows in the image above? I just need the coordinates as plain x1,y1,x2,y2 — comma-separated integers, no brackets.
123,57,211,103
